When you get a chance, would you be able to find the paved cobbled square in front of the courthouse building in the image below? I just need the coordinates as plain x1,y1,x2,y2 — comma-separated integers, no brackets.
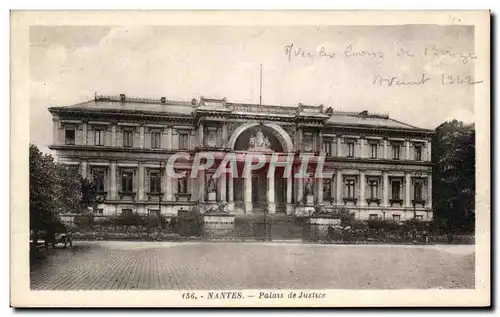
30,241,474,290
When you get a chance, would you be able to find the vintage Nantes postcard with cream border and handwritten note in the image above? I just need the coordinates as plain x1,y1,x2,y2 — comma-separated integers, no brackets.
10,11,491,307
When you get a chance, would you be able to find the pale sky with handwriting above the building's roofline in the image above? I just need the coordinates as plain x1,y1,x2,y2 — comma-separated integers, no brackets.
30,25,481,151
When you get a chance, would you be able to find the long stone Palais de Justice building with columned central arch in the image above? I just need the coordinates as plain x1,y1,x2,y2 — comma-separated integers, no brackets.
49,94,433,220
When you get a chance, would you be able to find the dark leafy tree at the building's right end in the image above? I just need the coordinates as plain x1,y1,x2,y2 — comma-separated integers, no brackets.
432,120,476,231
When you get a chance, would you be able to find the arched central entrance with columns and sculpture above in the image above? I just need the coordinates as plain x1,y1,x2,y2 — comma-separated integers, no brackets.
230,124,292,214
